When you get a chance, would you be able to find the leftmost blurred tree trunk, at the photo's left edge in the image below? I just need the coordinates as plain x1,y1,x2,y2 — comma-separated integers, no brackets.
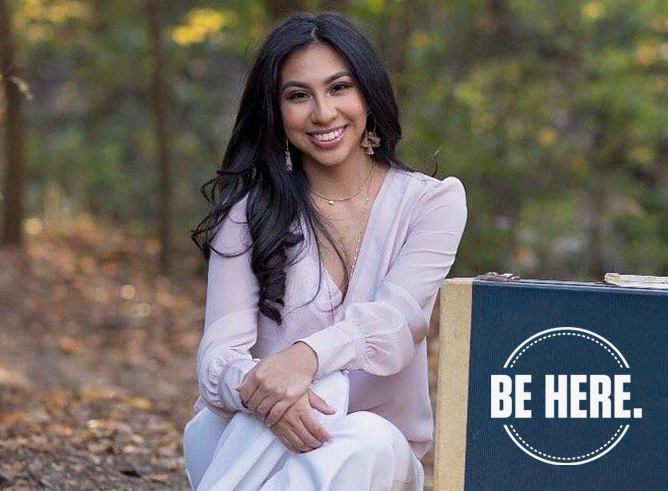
0,0,25,247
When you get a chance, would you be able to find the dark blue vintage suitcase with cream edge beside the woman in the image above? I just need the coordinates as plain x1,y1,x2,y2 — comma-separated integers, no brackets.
434,278,668,491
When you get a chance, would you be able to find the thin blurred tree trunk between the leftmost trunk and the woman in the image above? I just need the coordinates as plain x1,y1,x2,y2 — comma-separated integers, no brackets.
148,0,172,274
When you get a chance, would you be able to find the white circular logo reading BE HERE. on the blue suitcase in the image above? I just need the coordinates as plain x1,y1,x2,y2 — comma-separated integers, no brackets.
491,327,642,465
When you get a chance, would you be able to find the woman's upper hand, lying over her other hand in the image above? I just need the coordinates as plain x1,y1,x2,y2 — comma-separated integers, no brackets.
237,342,318,427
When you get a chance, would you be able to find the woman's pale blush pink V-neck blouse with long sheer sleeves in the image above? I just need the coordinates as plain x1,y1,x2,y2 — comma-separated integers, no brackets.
195,168,467,458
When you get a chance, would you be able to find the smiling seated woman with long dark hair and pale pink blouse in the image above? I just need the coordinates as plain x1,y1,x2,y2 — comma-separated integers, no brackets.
184,13,466,491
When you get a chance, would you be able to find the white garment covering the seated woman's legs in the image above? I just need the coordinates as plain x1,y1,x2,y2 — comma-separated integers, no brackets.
183,372,424,491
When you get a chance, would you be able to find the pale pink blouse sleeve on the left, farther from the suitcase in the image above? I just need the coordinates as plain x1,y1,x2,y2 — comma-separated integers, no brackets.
195,195,259,415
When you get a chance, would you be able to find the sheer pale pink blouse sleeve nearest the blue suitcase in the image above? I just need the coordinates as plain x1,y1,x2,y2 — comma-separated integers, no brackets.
300,177,467,377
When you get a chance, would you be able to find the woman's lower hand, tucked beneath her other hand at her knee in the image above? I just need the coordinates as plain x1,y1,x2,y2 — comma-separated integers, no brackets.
269,389,336,453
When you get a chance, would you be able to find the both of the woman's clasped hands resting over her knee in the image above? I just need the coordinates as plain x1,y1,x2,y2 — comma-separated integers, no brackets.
237,342,336,453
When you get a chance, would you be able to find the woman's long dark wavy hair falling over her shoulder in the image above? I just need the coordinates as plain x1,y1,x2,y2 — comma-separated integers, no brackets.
191,12,434,324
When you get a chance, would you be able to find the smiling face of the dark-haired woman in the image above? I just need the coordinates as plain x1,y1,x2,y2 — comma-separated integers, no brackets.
279,42,367,173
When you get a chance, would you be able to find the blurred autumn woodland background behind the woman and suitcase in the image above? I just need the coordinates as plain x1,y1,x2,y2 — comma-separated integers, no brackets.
0,0,668,489
